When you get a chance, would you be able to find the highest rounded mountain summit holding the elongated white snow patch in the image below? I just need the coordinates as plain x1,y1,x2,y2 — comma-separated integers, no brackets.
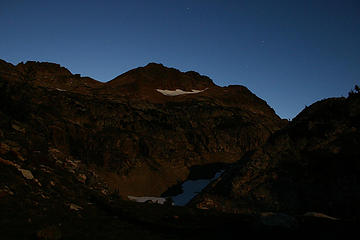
98,63,217,102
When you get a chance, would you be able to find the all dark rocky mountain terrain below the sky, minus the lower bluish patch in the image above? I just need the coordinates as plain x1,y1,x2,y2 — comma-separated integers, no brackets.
0,60,360,239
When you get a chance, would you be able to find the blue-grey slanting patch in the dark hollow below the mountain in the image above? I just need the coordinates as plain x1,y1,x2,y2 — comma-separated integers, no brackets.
171,170,224,206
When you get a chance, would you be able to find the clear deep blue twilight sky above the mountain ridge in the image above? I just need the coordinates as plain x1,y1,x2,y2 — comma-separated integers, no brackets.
0,0,360,118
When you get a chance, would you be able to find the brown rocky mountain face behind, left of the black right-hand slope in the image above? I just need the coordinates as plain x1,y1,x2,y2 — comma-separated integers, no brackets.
0,61,284,196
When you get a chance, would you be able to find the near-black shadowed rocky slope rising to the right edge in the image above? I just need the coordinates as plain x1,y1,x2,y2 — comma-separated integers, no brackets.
190,94,360,217
